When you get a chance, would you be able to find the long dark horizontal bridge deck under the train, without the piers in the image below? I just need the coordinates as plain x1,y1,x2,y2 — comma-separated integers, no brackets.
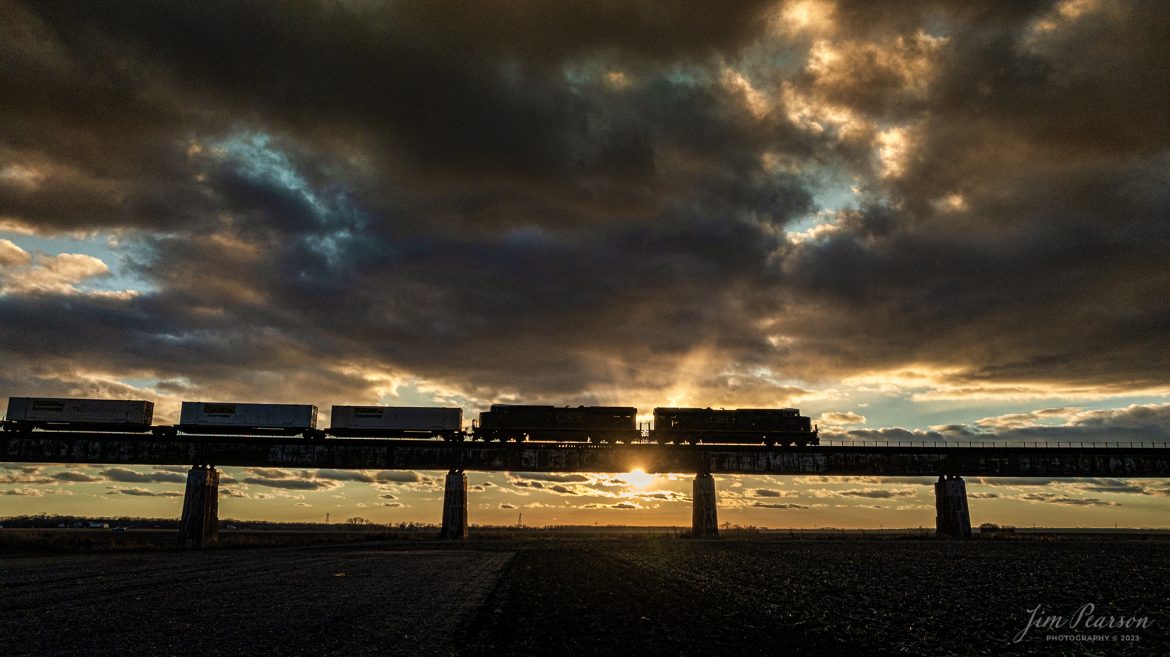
0,431,1170,477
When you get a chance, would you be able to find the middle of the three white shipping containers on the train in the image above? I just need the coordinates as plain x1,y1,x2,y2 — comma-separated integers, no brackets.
179,401,317,433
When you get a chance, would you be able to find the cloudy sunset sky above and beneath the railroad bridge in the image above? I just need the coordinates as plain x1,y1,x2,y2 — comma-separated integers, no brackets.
0,0,1170,527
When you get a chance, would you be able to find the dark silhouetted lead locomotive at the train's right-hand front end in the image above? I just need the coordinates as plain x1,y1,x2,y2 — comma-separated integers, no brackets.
651,408,820,447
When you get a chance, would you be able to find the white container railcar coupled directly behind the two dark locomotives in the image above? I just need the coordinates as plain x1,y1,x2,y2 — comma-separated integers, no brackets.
325,406,463,441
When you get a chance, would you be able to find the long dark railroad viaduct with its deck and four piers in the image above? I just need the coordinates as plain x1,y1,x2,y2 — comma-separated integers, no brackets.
0,431,1170,546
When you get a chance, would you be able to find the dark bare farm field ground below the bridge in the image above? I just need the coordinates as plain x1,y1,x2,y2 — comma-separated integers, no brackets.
0,538,1170,657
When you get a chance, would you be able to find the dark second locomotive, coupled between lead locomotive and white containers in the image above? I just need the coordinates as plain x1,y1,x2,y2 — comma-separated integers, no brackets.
474,403,641,443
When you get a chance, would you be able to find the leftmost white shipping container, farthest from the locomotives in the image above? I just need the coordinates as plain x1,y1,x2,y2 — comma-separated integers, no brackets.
7,397,154,429
